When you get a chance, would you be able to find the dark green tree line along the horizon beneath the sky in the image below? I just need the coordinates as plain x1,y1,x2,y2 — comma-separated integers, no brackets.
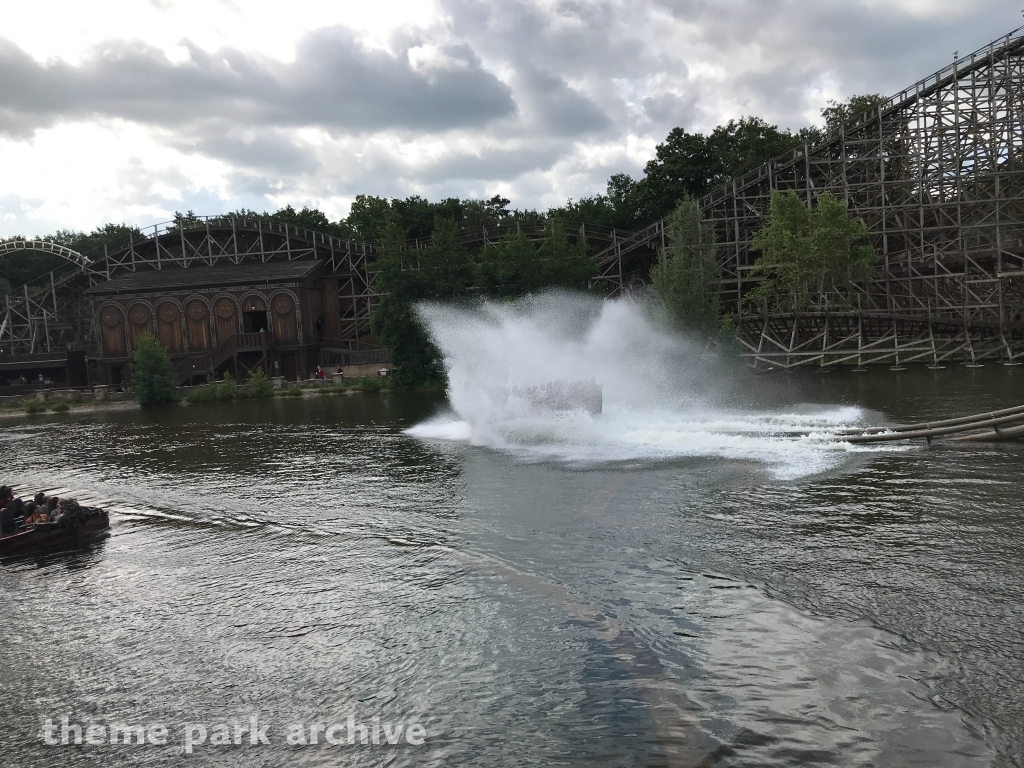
0,95,883,293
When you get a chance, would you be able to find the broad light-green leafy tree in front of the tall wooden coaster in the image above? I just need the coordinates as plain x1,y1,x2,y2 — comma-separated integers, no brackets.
748,189,874,307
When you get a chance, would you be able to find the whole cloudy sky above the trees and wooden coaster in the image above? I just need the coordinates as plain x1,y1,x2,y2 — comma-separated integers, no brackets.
0,0,1022,236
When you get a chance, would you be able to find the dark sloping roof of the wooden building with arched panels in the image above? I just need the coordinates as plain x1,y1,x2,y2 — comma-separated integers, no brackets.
86,260,324,295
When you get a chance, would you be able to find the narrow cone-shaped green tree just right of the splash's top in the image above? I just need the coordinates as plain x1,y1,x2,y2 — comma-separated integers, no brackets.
650,197,722,332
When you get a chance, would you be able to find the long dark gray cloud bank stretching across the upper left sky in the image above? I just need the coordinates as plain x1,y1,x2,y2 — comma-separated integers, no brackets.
0,29,515,135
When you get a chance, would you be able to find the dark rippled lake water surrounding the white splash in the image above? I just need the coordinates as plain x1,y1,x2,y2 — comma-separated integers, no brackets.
0,367,1024,766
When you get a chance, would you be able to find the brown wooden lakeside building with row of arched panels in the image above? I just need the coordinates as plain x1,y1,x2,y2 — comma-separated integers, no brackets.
86,260,341,385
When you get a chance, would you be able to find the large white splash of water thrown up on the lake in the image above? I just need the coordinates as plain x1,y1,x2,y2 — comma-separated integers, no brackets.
407,293,901,478
